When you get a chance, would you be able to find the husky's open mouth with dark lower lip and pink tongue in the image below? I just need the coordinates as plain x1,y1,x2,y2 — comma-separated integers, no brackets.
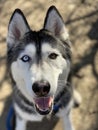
34,97,53,115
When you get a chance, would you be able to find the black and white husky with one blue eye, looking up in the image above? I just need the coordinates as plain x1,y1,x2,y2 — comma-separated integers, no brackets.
7,6,81,130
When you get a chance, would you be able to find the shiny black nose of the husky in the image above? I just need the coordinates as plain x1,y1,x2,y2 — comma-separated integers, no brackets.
32,80,50,96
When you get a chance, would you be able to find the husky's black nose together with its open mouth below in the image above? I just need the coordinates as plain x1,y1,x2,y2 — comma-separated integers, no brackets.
32,80,53,115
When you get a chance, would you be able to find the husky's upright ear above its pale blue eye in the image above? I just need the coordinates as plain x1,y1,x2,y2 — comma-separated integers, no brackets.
7,9,30,47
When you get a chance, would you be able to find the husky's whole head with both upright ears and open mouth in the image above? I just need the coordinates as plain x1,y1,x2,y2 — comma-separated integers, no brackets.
7,7,70,115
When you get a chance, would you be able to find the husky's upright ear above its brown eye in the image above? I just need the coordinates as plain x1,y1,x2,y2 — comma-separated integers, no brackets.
44,6,69,40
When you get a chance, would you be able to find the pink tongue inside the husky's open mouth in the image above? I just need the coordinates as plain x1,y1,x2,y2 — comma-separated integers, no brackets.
35,97,52,110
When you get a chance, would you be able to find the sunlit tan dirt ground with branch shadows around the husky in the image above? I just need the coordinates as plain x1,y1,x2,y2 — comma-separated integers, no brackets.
0,0,98,130
